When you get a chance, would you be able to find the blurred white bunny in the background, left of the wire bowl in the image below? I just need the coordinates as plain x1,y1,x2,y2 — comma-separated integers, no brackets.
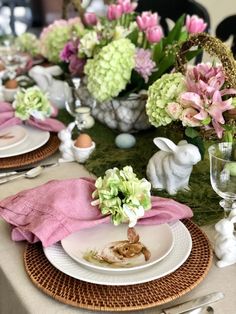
29,65,72,108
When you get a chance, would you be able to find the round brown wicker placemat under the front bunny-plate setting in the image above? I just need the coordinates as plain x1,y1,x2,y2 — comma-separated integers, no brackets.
24,220,213,311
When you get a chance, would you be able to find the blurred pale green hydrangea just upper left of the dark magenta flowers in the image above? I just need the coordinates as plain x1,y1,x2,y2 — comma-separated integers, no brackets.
40,23,71,63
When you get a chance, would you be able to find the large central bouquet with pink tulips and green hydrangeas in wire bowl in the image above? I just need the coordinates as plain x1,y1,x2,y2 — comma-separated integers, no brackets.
33,0,207,102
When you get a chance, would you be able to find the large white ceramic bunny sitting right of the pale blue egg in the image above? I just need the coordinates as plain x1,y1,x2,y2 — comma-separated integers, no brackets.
147,137,201,195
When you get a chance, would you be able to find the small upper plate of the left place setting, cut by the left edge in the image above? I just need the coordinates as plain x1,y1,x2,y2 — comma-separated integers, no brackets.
0,125,27,150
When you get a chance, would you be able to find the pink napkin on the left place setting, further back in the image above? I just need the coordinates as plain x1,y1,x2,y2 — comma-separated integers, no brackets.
0,101,65,132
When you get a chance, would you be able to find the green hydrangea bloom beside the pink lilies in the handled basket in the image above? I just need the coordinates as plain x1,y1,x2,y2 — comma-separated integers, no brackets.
146,73,186,127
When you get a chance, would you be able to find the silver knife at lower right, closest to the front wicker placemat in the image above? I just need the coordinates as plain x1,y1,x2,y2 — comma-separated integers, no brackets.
161,292,224,314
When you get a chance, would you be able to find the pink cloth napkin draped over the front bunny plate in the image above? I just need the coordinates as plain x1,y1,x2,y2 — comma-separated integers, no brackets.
0,178,193,247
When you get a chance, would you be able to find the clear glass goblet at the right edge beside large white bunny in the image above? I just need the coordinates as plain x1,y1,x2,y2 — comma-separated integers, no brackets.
208,142,236,215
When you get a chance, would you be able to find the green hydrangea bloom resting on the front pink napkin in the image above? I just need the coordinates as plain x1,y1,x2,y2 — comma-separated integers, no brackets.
92,166,151,227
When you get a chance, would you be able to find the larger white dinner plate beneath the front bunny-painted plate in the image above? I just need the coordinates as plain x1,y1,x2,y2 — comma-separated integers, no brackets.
44,221,192,286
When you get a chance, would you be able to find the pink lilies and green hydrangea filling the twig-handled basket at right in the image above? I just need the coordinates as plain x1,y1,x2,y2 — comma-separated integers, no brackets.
146,63,236,138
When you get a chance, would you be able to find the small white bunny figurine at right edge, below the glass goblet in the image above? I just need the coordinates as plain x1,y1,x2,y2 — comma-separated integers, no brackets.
214,213,236,267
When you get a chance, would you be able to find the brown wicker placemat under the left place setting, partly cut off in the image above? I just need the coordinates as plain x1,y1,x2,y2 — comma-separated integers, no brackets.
0,133,60,169
